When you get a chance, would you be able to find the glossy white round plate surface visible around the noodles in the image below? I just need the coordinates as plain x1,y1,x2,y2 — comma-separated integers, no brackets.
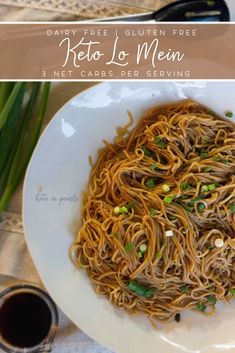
23,81,235,353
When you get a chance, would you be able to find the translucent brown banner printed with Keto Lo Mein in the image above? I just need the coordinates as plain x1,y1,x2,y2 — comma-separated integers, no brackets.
0,23,235,81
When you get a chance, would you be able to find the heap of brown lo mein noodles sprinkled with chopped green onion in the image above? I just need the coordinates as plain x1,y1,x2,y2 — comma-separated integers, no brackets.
70,101,235,321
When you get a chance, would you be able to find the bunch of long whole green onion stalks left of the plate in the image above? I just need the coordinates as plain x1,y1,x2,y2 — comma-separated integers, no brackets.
0,82,50,214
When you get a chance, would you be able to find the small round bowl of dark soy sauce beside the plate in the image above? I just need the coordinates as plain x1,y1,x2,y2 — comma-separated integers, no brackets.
0,286,58,352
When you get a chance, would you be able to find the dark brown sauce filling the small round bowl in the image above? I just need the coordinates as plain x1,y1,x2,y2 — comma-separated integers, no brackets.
0,293,52,348
